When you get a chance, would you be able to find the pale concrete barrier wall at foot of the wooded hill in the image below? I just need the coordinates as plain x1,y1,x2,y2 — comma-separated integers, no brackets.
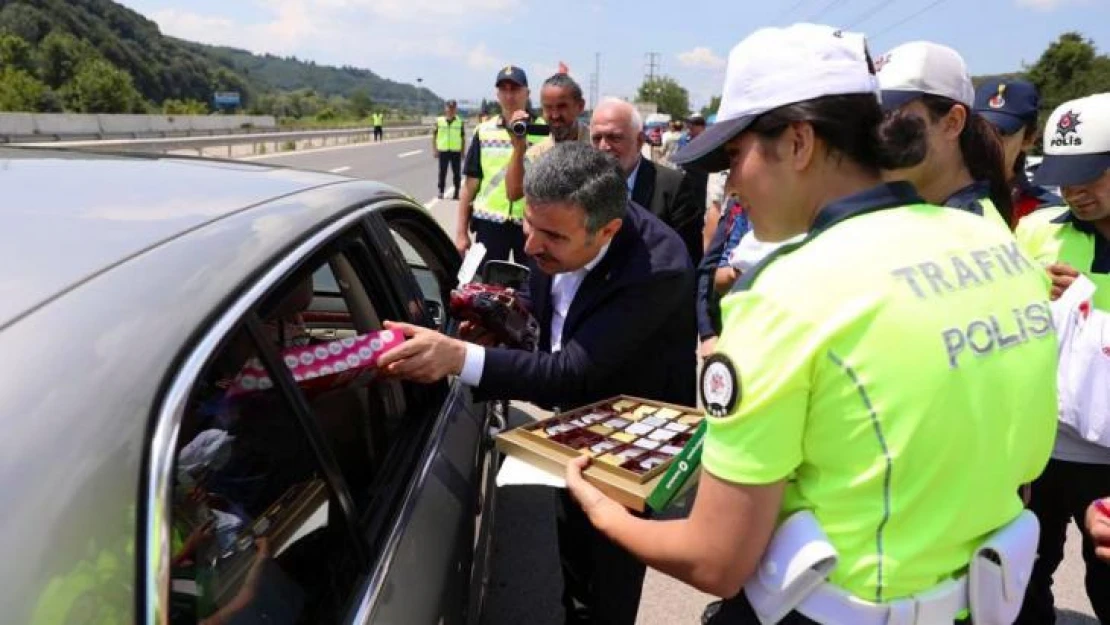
0,113,278,142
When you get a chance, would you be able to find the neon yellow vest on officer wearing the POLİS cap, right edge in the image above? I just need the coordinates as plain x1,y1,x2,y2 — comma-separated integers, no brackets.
1013,208,1110,311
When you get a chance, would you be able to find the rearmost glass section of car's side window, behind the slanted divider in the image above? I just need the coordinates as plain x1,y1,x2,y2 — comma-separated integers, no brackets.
170,323,361,625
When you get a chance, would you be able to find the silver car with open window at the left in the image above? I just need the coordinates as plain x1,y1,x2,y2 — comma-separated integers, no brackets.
0,148,498,625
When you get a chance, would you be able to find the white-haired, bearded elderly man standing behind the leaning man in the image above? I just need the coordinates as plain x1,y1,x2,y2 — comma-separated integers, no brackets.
589,99,705,264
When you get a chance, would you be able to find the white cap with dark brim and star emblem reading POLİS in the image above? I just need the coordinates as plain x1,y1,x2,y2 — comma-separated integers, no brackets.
1033,93,1110,187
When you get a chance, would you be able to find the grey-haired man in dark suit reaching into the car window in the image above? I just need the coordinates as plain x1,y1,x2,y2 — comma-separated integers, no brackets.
380,142,697,625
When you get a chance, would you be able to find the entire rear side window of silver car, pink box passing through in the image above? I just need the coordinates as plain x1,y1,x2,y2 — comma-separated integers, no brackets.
162,235,415,625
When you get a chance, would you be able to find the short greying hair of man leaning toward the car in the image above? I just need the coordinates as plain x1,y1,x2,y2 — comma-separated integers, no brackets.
524,141,628,234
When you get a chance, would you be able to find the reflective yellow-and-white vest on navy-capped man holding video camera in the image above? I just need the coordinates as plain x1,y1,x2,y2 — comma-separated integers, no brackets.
472,115,546,223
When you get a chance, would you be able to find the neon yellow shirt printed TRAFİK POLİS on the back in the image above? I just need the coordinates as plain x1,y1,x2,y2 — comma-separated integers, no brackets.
702,199,1057,603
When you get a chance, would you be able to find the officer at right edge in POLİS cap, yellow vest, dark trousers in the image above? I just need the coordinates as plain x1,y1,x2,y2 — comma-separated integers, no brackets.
1016,93,1110,625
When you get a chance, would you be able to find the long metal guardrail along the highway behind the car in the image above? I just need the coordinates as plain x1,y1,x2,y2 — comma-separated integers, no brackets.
11,125,433,157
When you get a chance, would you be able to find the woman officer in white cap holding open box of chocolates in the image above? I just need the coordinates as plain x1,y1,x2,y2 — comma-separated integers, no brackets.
566,24,1057,625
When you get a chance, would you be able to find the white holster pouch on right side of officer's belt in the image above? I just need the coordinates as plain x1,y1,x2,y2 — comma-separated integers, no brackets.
968,510,1040,625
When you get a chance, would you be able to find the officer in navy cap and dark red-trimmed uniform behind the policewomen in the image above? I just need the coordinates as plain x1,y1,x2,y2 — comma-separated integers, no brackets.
975,79,1063,226
